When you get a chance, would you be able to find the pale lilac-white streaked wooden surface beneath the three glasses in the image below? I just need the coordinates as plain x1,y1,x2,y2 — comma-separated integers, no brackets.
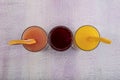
0,0,120,80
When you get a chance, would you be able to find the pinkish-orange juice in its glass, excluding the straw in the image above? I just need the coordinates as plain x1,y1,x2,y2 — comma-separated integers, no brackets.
22,26,47,52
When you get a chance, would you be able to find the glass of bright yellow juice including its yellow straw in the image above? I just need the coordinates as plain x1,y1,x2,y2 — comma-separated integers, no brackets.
74,25,111,51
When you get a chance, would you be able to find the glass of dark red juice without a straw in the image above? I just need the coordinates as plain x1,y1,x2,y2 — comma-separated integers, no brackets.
49,26,73,51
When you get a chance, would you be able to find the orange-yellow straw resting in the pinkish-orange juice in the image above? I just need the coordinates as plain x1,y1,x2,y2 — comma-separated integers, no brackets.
8,39,36,45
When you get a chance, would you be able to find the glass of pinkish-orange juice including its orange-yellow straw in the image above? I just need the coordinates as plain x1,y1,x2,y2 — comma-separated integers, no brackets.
9,26,47,52
